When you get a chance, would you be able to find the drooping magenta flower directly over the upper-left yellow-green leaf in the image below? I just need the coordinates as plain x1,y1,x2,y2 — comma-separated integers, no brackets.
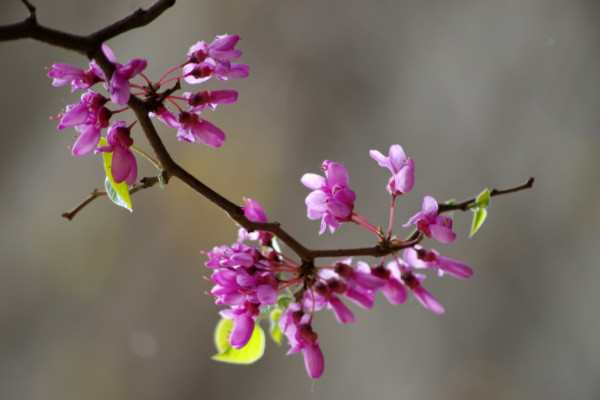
96,121,137,185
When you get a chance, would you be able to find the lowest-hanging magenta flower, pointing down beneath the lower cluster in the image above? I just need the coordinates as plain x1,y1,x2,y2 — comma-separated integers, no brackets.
279,303,325,379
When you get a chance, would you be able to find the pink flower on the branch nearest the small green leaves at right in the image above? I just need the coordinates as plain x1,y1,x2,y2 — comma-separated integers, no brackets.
402,196,456,243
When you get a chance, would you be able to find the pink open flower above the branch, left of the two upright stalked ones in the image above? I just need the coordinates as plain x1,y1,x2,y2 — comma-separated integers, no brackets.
301,160,356,235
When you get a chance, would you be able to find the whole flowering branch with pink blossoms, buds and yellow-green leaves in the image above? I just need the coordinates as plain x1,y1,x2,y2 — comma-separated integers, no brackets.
0,0,533,379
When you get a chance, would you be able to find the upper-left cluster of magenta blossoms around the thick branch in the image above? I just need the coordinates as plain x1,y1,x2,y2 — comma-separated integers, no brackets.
48,35,249,185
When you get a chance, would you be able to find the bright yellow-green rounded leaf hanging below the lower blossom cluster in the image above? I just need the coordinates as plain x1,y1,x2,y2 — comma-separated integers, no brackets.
212,318,265,364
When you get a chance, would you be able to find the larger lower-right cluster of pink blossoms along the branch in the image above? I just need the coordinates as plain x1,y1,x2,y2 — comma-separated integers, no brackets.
206,145,473,379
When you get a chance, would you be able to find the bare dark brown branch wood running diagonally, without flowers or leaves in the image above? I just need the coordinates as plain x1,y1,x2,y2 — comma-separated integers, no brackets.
0,0,533,264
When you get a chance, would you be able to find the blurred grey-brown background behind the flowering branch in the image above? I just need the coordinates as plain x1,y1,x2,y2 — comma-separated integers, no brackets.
0,0,600,400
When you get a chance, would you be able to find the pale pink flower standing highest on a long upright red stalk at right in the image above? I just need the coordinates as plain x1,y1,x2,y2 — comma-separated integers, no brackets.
369,144,415,196
